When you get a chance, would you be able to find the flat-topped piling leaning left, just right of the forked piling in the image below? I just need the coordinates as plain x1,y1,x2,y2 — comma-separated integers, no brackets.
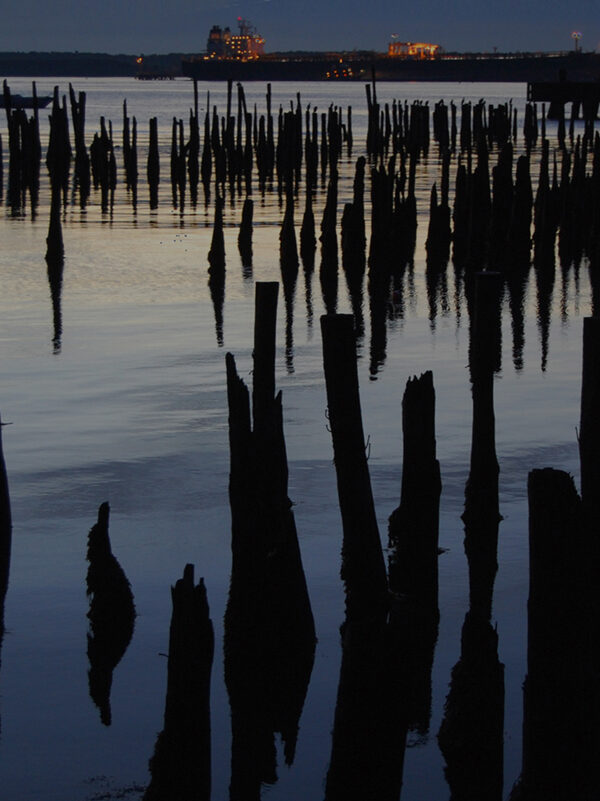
321,314,388,620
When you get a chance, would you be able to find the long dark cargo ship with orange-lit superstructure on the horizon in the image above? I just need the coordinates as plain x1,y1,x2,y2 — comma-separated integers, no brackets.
181,17,600,83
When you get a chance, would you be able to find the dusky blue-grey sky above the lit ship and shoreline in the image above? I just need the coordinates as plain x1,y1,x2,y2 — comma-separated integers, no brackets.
0,0,600,54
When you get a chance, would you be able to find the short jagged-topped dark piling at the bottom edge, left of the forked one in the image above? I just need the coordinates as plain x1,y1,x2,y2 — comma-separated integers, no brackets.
144,564,214,801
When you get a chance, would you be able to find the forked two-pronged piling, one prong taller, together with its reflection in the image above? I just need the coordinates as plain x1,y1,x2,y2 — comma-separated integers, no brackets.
225,283,315,800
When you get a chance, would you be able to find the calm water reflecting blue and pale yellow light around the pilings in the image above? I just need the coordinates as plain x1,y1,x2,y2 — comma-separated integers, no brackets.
0,73,590,801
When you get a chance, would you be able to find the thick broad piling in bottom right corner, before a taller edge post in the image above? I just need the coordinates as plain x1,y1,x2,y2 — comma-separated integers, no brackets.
511,468,600,801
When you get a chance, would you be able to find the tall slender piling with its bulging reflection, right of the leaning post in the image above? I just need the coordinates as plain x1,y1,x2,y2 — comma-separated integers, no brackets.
438,272,504,801
